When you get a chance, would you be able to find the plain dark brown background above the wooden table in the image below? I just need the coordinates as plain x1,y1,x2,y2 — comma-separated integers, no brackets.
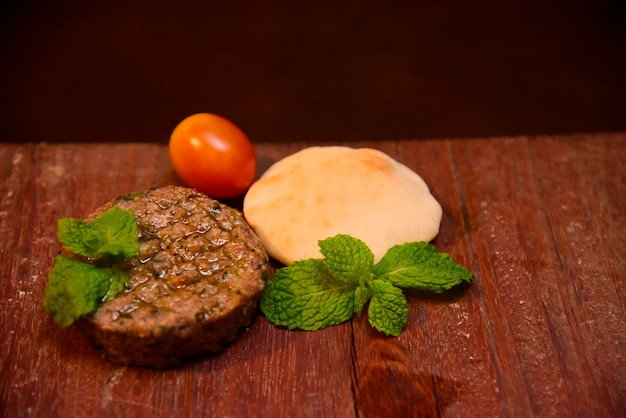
0,0,626,142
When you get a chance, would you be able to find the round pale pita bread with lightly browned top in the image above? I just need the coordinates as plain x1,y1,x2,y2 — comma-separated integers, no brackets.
243,146,442,265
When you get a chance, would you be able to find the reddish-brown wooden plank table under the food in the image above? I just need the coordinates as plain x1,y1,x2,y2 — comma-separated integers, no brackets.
0,133,626,417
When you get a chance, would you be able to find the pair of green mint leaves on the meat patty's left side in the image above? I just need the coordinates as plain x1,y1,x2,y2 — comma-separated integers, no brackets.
44,206,139,328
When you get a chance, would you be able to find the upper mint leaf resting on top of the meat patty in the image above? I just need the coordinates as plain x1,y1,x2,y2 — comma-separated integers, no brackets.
58,206,139,261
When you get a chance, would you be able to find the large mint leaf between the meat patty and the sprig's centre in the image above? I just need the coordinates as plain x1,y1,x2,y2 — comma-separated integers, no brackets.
260,259,355,330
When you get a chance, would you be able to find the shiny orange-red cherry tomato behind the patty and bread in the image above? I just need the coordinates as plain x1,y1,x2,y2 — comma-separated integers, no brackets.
169,113,256,199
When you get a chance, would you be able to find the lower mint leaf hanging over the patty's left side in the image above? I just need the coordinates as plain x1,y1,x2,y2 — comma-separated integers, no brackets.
44,256,127,328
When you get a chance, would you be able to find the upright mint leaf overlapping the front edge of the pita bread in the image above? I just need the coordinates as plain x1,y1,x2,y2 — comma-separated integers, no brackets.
318,235,374,284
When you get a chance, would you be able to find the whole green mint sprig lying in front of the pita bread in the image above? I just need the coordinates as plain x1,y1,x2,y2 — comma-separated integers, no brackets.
260,235,472,336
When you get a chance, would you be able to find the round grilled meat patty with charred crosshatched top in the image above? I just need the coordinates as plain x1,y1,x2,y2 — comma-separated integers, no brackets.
77,186,268,368
